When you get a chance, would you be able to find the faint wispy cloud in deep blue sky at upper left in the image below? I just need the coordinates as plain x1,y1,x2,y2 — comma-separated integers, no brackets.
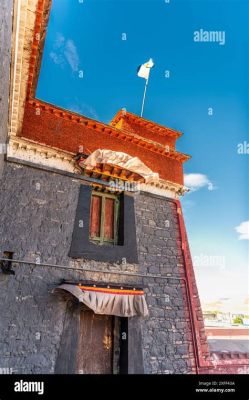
49,33,80,72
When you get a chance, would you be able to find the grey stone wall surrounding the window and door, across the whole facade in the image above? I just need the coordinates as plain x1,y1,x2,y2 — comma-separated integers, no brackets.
0,163,194,374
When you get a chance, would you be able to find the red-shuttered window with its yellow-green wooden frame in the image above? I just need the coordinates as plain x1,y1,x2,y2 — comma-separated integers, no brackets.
90,192,119,245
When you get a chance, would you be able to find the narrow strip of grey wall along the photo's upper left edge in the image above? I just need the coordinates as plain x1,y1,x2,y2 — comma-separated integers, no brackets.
0,0,13,176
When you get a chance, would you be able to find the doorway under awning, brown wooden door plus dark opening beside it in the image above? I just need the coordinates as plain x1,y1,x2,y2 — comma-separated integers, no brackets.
76,307,128,374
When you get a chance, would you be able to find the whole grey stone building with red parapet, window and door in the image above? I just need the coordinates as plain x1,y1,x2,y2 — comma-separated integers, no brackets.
0,0,249,374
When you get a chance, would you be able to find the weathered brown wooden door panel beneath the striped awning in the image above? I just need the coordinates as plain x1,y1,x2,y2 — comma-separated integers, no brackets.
76,310,114,374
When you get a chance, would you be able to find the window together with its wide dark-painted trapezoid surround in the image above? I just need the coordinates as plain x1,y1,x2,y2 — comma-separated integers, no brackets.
69,185,138,264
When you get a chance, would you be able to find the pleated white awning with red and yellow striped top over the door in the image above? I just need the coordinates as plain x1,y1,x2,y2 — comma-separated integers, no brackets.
56,283,149,317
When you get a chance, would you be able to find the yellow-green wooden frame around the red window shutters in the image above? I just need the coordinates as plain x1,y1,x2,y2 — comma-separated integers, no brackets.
89,191,120,246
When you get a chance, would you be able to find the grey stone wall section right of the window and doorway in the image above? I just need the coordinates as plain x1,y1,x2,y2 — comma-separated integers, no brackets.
136,194,191,374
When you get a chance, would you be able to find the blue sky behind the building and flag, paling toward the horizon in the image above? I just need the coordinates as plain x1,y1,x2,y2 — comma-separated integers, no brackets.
36,0,249,302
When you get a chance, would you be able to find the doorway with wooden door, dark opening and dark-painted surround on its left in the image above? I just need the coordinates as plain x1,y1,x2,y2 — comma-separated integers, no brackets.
55,301,128,374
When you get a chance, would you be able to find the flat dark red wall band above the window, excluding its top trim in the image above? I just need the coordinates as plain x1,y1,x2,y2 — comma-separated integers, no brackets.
21,102,183,184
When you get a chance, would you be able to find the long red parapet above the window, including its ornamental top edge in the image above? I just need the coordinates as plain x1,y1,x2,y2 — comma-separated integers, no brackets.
21,99,189,185
